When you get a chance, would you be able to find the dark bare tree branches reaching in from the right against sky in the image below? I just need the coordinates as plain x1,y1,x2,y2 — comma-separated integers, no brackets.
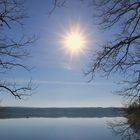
86,0,140,102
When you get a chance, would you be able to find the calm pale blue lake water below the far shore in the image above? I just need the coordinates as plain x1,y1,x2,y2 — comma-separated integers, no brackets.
0,117,124,140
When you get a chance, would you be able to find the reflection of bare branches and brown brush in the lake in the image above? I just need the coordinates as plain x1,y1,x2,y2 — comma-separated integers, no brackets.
107,114,140,140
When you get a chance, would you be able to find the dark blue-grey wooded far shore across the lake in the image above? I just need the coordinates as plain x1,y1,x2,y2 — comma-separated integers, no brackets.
0,107,125,119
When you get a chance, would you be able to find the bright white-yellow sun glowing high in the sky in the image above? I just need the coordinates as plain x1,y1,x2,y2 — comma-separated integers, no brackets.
61,24,87,56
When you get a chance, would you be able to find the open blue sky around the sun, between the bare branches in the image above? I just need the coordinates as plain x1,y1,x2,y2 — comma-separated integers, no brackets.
1,0,121,107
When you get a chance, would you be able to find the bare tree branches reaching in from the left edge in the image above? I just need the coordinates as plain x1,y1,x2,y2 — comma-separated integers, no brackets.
0,0,35,99
